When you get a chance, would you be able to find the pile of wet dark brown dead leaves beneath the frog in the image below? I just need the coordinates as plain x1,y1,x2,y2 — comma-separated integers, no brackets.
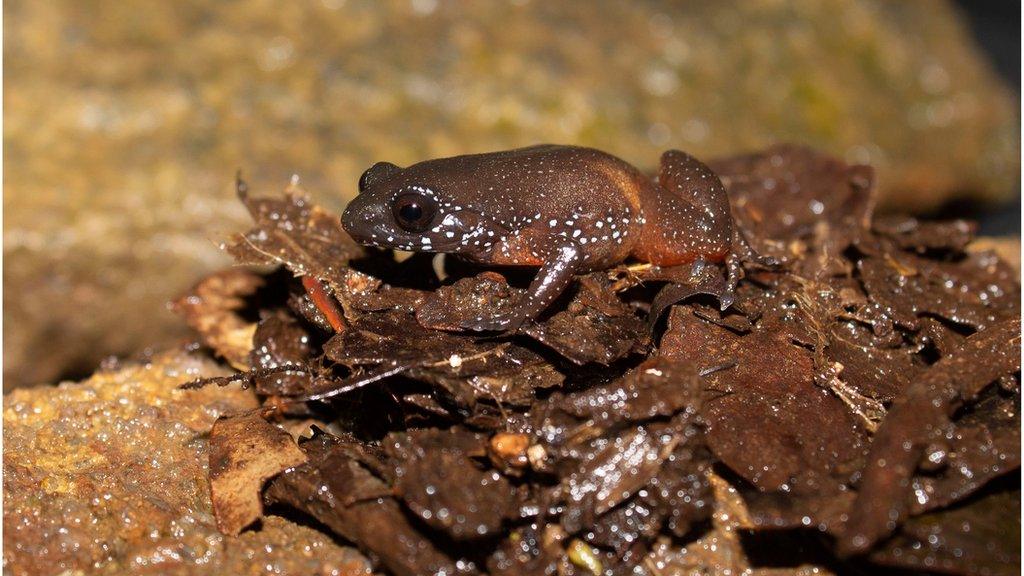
178,147,1021,574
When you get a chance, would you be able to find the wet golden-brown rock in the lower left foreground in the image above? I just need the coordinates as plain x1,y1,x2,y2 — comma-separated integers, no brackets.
3,352,370,575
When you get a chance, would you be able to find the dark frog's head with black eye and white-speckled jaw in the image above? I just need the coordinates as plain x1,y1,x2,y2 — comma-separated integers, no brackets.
341,155,509,253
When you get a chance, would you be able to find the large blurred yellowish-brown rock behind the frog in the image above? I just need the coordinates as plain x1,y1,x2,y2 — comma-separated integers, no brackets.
3,0,1020,389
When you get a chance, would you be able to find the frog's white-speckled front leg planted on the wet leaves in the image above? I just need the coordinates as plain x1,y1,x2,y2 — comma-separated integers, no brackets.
463,239,583,333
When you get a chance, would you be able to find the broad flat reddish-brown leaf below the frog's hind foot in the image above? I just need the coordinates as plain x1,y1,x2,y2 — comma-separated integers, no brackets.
659,306,866,494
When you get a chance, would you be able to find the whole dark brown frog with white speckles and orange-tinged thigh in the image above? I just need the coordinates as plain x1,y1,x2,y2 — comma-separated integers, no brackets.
342,145,749,331
